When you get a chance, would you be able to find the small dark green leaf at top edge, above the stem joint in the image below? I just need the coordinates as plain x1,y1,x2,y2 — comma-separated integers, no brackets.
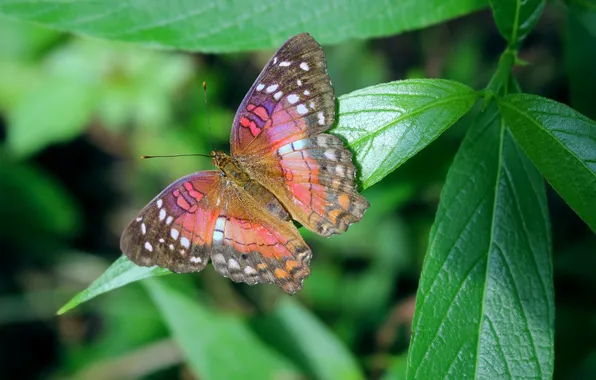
490,0,546,47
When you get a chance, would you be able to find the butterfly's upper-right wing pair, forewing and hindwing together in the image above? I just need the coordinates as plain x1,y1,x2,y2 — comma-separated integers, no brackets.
231,34,369,236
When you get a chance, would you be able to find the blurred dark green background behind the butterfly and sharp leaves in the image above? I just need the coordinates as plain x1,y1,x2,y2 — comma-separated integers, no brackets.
0,6,596,379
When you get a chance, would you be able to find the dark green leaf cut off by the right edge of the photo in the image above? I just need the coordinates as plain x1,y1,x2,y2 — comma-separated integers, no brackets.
499,94,596,231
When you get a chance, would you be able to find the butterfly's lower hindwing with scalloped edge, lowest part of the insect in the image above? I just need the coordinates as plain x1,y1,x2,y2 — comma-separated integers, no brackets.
211,181,312,294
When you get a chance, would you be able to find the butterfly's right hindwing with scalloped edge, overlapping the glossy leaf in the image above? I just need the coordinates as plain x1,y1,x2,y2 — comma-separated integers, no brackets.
248,133,369,236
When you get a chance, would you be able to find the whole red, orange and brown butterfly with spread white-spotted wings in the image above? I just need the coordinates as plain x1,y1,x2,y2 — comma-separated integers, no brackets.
120,33,369,294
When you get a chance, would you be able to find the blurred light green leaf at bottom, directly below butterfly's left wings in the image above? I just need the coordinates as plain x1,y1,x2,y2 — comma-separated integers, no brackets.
143,279,298,380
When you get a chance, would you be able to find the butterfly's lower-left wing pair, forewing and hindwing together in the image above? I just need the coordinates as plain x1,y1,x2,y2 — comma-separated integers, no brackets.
120,171,311,294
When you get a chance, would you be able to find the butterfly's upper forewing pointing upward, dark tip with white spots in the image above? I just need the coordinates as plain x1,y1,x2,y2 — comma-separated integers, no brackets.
230,33,335,156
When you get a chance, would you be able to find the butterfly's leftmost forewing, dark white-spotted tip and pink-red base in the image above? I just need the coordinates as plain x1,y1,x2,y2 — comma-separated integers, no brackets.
120,171,222,273
